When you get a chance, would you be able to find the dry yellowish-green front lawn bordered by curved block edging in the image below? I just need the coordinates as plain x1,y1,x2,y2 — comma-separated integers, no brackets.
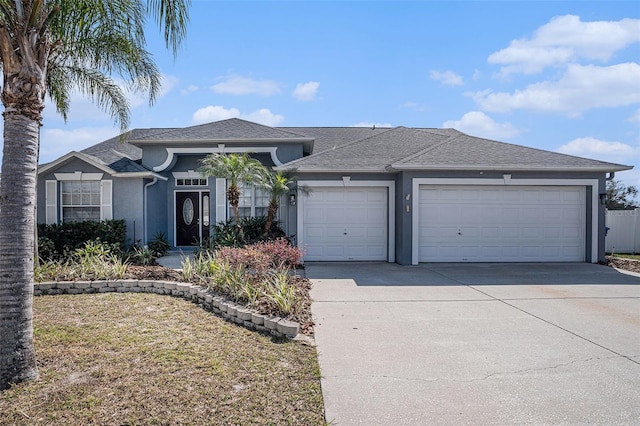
0,293,324,425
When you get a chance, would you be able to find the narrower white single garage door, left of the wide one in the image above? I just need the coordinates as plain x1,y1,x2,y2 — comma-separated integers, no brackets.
300,187,388,261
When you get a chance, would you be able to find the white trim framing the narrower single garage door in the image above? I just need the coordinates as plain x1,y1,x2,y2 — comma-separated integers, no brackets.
296,176,396,262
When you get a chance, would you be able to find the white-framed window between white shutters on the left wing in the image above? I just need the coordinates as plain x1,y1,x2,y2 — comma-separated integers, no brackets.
60,181,101,222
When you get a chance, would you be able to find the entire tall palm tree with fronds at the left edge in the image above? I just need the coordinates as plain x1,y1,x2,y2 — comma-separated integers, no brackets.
0,0,190,390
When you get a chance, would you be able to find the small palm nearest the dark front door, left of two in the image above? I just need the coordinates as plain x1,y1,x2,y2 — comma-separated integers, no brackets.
198,152,265,225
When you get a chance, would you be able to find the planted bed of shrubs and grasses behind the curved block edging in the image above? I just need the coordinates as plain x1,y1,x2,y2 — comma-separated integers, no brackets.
36,239,313,335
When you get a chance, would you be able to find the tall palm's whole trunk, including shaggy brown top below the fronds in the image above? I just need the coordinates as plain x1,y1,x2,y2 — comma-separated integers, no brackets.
0,27,50,389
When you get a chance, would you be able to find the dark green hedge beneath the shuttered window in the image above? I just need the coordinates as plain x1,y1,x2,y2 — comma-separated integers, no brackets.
38,220,127,261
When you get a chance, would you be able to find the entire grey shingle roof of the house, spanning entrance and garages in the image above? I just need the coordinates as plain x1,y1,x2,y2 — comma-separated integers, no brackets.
70,118,631,172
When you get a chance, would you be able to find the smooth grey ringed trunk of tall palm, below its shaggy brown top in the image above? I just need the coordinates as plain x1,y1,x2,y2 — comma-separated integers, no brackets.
0,111,40,389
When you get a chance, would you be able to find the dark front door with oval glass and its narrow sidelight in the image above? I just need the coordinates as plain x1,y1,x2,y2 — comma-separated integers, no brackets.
175,191,210,246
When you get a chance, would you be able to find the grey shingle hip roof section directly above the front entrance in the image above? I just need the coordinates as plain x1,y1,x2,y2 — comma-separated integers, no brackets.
131,118,309,145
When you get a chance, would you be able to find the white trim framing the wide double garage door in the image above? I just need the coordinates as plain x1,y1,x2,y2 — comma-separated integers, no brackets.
411,175,600,265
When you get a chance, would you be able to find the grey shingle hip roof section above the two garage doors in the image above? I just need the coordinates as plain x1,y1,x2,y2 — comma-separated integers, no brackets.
279,127,630,172
